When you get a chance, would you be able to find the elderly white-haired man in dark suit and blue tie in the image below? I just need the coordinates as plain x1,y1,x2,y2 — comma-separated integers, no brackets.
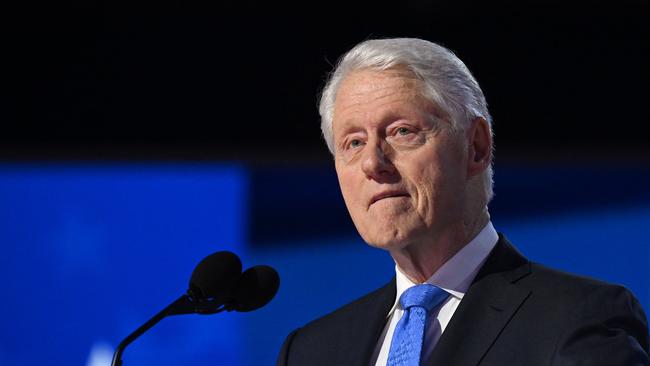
277,39,650,366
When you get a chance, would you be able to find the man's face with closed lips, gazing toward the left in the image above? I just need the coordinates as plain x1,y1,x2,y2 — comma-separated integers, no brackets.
333,70,468,250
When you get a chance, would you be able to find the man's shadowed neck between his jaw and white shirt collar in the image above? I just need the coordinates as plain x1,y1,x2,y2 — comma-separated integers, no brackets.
390,208,490,283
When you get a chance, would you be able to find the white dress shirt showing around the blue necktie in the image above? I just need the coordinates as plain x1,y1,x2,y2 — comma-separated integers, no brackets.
370,222,499,366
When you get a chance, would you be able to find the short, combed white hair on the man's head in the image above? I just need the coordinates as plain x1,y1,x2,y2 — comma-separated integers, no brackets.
319,38,494,203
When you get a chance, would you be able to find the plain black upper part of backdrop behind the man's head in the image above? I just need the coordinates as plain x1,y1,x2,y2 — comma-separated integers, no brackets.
0,0,650,159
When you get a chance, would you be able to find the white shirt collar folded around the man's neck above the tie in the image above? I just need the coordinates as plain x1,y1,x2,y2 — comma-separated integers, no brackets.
388,222,499,316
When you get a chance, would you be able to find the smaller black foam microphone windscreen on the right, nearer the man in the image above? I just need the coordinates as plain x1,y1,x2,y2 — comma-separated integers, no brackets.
232,265,280,311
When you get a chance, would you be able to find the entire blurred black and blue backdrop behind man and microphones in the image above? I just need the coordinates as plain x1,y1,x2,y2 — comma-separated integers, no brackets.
0,1,650,366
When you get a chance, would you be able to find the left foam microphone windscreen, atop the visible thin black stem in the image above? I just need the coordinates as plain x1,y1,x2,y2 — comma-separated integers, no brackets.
190,251,242,303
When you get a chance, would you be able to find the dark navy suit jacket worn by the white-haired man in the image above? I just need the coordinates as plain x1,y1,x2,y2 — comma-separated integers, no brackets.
277,235,650,366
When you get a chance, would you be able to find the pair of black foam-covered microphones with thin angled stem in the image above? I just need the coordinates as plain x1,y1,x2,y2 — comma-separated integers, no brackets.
111,251,280,366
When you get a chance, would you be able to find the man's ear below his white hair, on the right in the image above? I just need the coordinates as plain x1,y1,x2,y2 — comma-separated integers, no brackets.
467,117,492,177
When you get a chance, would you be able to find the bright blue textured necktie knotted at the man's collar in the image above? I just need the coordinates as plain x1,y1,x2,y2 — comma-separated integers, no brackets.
387,284,449,366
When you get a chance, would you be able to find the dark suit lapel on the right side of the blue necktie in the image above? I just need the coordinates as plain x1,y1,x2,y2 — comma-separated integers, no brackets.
430,235,531,366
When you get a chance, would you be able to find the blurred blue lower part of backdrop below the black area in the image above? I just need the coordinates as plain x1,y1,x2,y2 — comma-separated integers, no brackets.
0,163,650,366
